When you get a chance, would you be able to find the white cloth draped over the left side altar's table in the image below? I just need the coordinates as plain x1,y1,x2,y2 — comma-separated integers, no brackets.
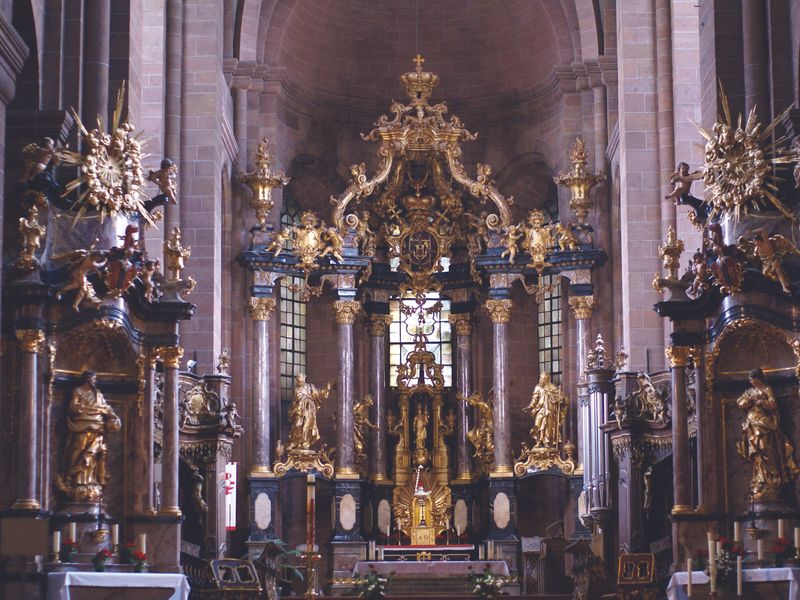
47,571,189,600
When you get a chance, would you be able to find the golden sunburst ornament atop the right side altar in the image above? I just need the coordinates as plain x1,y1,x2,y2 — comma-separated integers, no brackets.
697,85,794,220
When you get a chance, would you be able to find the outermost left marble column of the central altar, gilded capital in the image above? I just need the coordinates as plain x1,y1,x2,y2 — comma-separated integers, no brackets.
250,296,275,476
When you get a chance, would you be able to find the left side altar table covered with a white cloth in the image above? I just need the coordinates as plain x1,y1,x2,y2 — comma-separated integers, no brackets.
47,571,189,600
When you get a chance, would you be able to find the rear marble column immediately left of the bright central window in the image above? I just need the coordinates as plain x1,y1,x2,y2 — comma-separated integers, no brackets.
369,313,390,481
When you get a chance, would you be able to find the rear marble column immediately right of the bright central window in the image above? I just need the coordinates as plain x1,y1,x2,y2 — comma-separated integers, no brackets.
450,313,472,482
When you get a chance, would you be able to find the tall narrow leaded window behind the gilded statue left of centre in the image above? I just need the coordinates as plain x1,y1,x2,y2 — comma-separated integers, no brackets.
280,195,307,425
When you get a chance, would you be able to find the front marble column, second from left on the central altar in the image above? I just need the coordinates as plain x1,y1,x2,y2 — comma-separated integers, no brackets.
333,300,361,479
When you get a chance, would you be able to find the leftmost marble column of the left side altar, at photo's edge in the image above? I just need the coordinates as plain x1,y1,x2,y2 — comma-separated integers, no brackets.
11,329,44,510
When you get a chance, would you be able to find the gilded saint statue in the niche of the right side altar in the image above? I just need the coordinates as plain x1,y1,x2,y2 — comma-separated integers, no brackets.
736,369,800,500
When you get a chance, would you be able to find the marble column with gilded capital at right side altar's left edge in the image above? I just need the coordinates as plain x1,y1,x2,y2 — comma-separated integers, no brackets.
665,346,692,514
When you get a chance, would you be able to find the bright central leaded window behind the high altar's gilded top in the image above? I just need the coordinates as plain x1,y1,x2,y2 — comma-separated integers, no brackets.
389,292,453,387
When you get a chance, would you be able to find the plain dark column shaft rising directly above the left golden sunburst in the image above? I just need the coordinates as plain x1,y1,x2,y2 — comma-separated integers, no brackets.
82,0,111,130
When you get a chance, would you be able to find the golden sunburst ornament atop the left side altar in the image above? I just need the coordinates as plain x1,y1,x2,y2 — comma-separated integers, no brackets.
61,89,155,226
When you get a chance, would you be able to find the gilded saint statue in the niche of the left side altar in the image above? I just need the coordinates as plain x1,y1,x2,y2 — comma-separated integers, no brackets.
56,371,121,502
